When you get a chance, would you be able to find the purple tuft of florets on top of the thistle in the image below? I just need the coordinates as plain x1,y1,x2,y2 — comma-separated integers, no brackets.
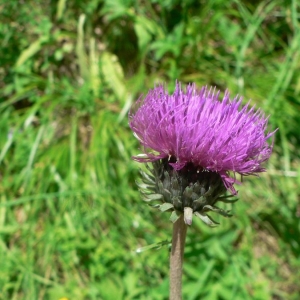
129,83,275,194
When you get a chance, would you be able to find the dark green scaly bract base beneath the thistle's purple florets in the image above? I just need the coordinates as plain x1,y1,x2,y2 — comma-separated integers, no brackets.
137,158,237,226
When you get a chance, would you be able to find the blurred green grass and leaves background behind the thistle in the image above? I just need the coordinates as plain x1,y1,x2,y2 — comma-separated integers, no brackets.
0,0,300,300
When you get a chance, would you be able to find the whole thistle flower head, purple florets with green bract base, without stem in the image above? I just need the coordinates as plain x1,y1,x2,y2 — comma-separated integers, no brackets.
129,83,275,225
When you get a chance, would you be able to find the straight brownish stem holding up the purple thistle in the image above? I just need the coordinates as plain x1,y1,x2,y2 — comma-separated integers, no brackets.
170,214,187,300
